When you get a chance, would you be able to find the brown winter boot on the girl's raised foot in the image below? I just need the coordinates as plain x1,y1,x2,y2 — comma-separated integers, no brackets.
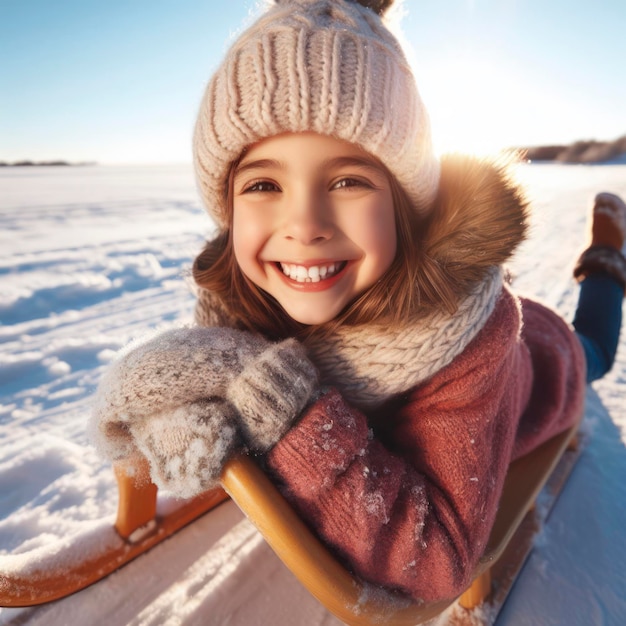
574,193,626,292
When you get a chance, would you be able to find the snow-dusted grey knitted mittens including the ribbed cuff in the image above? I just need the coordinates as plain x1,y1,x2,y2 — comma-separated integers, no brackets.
91,327,317,497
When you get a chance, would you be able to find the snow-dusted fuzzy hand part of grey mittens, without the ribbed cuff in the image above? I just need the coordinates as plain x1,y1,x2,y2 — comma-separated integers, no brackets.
90,328,270,497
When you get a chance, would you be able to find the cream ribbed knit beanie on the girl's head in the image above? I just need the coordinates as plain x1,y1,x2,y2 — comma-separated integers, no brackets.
194,0,439,228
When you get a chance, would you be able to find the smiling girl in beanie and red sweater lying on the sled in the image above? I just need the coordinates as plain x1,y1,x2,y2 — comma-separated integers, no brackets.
94,0,626,600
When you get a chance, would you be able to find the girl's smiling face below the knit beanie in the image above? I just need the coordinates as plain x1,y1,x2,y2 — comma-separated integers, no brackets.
233,133,396,324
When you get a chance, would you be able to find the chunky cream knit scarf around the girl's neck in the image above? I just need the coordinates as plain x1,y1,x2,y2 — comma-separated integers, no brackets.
196,268,503,411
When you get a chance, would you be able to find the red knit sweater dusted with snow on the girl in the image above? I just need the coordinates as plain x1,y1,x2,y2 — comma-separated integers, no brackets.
268,291,585,601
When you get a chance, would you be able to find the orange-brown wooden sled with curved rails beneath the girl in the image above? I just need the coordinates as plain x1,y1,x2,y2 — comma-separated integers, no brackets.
0,416,580,626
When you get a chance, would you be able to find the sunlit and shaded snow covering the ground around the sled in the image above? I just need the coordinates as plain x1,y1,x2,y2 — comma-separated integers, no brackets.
0,164,626,626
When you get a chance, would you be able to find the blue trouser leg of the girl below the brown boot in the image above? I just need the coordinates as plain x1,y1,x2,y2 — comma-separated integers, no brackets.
573,274,624,383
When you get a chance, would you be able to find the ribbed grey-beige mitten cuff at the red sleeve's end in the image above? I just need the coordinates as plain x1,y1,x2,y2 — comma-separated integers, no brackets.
226,339,318,452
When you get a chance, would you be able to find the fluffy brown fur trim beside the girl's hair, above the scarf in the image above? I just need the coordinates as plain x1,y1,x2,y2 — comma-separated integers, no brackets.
420,154,529,303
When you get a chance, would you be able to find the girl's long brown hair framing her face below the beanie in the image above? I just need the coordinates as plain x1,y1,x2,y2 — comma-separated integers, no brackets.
192,158,457,339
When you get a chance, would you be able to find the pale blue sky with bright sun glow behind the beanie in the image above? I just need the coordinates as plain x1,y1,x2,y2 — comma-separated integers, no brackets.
0,0,626,163
